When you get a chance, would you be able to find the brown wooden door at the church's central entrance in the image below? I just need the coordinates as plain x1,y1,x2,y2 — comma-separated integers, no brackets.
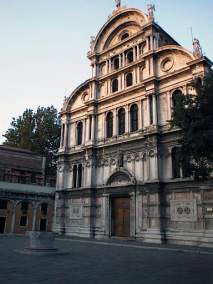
112,197,130,237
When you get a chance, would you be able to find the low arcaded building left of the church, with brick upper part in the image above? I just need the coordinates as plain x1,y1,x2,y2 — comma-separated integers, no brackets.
0,146,55,234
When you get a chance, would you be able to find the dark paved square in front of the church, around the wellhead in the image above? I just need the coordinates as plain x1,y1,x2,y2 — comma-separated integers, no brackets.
0,236,213,284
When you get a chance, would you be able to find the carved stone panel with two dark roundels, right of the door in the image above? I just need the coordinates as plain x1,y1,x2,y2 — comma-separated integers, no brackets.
170,199,197,222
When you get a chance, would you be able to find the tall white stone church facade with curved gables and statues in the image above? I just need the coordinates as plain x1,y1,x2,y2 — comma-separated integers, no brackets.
55,1,213,246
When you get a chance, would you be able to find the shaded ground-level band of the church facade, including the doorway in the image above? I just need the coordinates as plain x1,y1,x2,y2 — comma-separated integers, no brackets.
55,180,213,247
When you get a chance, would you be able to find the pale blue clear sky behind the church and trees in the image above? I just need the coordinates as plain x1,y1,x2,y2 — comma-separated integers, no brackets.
0,0,213,143
